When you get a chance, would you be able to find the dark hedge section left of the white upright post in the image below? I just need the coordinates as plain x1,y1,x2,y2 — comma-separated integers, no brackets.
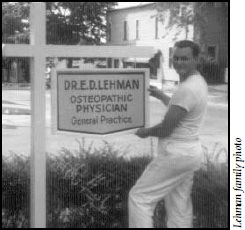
2,153,30,228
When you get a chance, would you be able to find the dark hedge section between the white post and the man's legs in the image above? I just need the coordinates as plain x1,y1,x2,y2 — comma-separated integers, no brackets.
47,144,150,228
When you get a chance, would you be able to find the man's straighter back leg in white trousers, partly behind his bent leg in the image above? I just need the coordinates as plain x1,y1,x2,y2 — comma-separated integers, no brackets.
164,173,193,228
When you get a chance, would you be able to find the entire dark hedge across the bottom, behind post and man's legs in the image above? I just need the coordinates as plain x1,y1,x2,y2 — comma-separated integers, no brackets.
2,143,228,228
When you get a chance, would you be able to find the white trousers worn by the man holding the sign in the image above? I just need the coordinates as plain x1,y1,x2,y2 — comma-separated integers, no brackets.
128,141,202,228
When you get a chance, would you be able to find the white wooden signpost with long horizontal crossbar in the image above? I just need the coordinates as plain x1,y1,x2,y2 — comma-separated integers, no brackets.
2,2,154,228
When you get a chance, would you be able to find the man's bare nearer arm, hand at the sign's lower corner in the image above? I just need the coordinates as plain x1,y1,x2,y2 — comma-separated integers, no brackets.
135,105,187,138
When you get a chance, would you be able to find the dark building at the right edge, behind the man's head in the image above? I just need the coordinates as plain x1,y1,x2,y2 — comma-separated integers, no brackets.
194,2,229,83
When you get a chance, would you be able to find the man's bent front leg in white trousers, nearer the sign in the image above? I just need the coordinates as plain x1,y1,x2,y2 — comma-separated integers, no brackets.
128,156,196,228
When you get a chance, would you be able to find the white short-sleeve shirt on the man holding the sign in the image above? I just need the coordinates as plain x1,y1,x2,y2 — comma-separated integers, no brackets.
167,74,208,141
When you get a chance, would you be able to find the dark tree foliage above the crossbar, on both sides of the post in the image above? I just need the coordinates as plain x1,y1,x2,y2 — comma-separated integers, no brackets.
2,2,117,45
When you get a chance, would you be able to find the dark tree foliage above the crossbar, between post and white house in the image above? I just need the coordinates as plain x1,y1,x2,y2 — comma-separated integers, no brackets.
47,2,116,44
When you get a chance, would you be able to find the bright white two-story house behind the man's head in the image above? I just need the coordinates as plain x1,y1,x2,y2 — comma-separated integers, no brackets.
107,3,194,87
